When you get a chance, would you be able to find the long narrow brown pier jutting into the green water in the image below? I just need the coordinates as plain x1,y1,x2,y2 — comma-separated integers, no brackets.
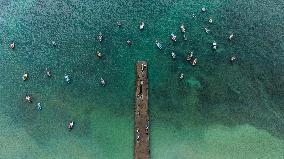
134,61,150,159
